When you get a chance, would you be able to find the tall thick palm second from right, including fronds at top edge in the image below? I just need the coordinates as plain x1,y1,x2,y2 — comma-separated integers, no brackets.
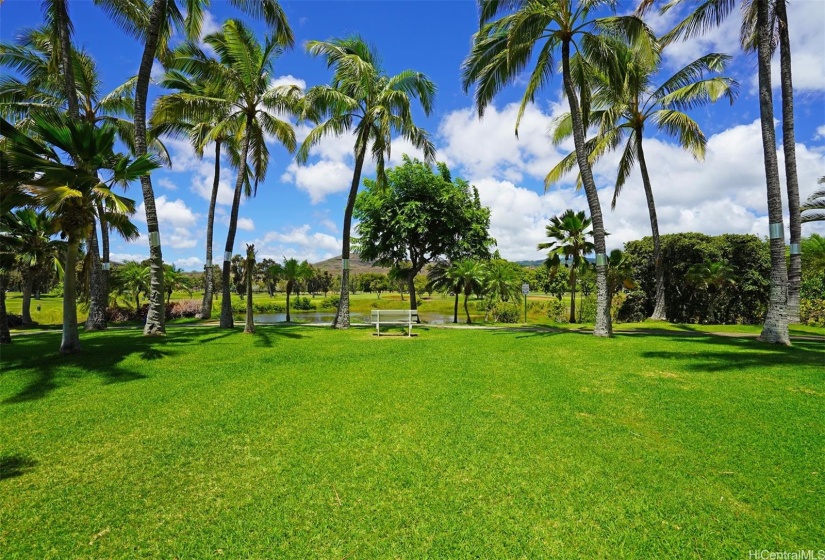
640,0,788,346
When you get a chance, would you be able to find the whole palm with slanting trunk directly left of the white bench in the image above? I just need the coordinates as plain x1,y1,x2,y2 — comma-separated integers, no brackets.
297,36,435,329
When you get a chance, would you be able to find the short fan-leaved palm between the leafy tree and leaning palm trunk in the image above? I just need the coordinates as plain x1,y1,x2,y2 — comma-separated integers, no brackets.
538,210,592,323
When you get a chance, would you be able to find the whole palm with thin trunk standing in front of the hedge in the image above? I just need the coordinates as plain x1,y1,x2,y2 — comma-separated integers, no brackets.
545,40,737,321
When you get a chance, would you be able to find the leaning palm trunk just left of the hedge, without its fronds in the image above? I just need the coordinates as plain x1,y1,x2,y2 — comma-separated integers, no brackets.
561,39,613,336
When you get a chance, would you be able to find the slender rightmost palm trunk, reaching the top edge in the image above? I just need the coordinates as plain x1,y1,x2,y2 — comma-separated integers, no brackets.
775,0,802,323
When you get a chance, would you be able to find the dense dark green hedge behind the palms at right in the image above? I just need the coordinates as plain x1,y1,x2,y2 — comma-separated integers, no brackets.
625,233,770,324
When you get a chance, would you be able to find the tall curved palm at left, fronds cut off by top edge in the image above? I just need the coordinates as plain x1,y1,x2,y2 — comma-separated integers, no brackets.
95,0,295,335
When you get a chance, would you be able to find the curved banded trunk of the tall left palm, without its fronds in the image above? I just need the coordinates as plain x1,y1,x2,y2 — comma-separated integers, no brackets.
135,0,168,336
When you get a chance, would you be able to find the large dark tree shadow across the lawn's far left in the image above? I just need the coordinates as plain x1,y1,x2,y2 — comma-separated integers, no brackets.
2,329,237,405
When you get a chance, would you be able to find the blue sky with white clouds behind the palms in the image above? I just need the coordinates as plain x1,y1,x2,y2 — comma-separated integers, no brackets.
0,0,825,270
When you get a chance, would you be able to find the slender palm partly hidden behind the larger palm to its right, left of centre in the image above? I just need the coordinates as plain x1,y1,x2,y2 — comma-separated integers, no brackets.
150,43,243,318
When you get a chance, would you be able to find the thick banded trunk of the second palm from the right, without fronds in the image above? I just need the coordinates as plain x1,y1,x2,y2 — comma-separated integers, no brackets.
755,0,791,346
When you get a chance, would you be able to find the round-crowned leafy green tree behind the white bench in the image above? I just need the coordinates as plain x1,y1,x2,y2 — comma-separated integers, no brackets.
354,155,493,311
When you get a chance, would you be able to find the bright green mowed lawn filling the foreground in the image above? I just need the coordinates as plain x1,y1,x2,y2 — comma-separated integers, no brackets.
0,326,825,559
